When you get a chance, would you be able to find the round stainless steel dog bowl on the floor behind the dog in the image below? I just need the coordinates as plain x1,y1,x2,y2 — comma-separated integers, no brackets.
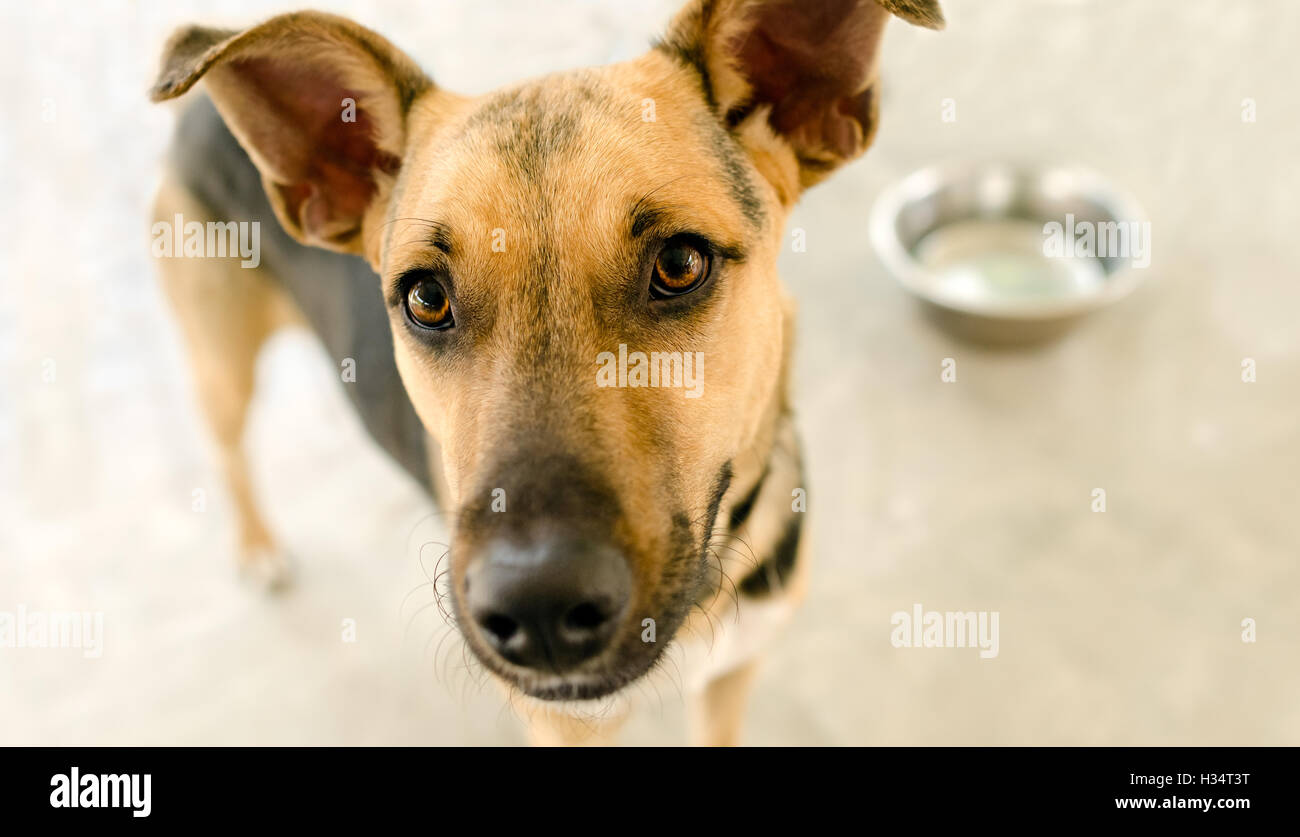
871,164,1151,342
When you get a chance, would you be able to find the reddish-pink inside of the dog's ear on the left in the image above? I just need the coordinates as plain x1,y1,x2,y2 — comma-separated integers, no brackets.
229,57,399,243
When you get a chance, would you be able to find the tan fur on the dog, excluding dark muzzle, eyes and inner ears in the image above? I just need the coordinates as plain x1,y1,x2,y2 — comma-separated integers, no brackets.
153,0,941,743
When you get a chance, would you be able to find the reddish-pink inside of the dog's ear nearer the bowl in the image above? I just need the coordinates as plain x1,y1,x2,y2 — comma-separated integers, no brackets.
735,0,888,157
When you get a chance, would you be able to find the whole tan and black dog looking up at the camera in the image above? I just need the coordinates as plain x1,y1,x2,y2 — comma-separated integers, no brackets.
151,0,944,745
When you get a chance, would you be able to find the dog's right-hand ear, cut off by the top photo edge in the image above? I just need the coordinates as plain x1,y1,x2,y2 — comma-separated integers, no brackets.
660,0,944,204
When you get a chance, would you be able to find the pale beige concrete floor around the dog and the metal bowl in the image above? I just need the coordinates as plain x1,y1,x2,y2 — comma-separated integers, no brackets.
0,0,1300,745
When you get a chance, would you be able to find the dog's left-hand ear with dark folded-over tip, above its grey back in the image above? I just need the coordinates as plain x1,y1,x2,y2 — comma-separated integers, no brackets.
151,12,432,264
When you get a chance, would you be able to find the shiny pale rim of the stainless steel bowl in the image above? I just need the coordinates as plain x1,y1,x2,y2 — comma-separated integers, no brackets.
868,160,1151,321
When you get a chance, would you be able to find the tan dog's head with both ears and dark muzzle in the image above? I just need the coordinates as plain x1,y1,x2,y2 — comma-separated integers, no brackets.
153,0,941,699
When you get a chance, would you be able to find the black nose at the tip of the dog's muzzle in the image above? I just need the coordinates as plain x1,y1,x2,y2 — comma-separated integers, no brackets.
465,539,631,672
